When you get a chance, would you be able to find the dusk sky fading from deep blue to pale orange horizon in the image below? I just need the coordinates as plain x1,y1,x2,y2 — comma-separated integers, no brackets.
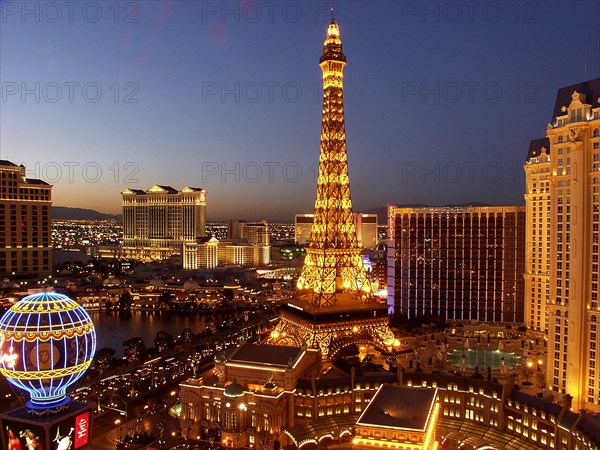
0,0,600,222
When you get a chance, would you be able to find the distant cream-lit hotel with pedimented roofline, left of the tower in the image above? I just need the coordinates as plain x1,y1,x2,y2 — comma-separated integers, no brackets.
121,185,206,261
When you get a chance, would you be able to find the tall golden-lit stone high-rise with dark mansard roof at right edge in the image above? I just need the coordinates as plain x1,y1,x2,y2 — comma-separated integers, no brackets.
525,78,600,412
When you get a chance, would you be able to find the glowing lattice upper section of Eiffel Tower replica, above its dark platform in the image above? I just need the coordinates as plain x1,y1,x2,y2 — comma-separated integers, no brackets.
298,20,372,307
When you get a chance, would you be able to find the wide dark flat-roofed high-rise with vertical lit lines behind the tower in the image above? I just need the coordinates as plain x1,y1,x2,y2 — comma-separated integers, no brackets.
387,205,525,323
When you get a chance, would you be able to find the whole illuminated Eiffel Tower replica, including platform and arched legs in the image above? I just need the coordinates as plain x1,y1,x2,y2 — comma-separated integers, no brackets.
270,17,398,359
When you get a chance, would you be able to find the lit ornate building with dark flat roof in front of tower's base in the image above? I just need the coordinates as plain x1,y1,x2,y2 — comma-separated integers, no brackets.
179,344,321,448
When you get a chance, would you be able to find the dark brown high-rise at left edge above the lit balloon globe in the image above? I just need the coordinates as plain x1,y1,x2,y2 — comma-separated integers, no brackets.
0,160,52,276
